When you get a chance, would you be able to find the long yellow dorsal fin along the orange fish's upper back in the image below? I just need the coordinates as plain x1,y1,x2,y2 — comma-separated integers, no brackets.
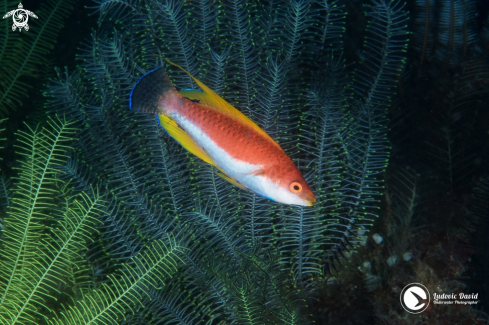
165,59,278,146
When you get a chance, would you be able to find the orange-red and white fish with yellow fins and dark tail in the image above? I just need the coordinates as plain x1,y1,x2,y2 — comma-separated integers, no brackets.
129,60,316,206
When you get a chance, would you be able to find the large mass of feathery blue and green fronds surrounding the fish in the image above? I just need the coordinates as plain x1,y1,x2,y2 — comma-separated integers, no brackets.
0,0,408,324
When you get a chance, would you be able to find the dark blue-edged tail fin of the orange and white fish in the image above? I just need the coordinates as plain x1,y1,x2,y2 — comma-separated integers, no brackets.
129,67,176,114
